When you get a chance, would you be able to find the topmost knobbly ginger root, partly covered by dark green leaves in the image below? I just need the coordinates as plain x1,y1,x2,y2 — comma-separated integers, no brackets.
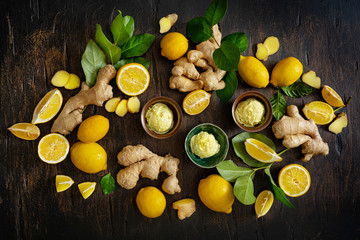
169,25,226,92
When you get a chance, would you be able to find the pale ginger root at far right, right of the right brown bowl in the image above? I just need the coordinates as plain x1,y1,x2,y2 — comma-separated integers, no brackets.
272,105,329,162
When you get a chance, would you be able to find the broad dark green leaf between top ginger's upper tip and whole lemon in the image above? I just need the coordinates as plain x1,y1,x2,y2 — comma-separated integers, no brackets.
213,41,240,71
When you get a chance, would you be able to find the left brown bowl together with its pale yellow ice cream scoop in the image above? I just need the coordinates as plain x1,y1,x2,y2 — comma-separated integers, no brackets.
141,96,182,139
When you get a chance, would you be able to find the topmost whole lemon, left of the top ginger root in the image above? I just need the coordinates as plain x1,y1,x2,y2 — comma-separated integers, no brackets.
160,32,189,60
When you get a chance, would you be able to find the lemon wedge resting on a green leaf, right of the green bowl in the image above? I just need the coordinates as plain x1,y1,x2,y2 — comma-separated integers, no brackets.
245,138,282,163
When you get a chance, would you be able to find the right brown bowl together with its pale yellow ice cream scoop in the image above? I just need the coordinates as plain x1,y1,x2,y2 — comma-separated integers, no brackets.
232,91,272,132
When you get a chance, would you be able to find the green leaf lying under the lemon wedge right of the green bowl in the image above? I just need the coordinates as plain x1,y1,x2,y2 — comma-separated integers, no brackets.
231,132,276,167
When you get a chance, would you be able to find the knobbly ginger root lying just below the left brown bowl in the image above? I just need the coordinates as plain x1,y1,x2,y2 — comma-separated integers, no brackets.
117,144,181,194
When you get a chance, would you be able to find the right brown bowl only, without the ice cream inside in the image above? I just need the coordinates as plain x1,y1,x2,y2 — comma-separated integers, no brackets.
231,91,272,132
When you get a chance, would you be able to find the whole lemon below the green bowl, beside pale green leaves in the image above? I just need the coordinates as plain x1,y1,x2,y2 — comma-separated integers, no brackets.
198,174,235,213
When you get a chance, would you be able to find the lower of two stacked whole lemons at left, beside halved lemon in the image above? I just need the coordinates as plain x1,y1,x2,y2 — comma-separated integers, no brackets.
70,142,107,173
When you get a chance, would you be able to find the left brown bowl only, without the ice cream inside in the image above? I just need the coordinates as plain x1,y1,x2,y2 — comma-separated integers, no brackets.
141,96,182,139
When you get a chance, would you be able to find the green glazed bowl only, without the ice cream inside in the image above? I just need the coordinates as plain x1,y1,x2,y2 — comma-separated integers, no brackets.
185,123,229,168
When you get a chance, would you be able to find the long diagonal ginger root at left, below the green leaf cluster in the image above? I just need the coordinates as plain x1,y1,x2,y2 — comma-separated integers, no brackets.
51,65,116,135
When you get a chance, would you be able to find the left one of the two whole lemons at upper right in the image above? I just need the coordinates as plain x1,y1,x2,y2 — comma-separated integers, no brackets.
238,56,269,88
